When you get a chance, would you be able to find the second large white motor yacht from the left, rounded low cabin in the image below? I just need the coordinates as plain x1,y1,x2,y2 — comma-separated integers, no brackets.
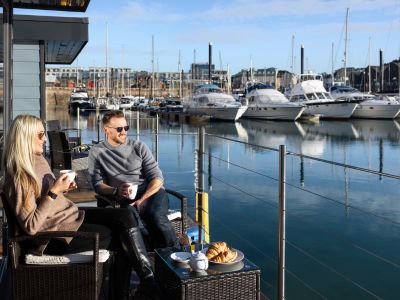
243,83,305,121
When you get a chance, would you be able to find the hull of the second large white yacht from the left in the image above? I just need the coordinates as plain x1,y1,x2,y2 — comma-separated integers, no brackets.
243,105,305,121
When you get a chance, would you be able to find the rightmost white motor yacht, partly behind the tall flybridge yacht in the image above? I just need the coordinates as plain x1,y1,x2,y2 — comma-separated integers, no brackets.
331,86,400,119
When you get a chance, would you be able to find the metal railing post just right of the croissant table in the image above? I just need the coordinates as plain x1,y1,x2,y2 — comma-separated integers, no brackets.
278,145,286,300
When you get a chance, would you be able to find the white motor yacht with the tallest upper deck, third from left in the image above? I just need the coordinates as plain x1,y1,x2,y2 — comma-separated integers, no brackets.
289,74,358,119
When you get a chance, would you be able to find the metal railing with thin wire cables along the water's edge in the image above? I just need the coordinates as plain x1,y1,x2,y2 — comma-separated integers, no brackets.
65,107,400,299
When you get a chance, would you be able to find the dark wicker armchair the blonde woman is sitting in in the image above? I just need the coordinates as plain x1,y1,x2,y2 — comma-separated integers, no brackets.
1,193,113,300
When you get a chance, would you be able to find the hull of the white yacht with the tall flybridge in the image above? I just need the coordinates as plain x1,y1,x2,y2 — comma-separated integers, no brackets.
303,102,358,119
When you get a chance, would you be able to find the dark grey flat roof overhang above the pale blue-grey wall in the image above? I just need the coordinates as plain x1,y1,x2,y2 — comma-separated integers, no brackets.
0,15,89,64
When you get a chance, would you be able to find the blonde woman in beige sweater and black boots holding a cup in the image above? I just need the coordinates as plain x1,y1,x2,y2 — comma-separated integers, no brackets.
2,115,157,298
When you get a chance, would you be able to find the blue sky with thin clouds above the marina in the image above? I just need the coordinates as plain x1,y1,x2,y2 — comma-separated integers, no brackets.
15,0,400,74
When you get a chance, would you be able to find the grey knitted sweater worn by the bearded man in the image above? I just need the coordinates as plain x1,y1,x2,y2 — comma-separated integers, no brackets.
89,138,164,195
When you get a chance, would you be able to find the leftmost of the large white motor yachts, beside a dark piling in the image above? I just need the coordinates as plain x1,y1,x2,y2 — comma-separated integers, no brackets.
183,84,247,121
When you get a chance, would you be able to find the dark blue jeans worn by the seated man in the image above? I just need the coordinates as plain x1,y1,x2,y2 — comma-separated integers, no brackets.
123,189,179,248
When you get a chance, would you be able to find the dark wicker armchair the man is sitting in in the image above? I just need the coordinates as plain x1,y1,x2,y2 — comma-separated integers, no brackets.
96,189,188,238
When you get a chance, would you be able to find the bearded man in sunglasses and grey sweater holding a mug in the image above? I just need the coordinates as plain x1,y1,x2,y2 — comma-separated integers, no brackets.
89,110,179,247
